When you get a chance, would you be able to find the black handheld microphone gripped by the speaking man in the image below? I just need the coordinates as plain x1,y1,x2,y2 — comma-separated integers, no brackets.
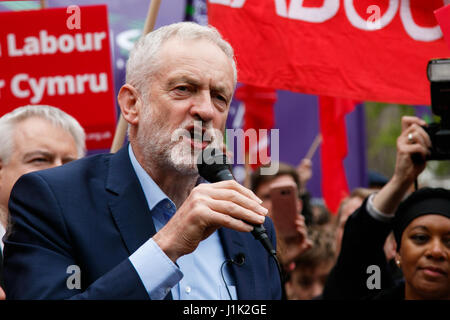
197,148,276,256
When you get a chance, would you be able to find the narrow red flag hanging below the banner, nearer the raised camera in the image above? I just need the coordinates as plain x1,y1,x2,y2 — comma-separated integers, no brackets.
319,96,356,214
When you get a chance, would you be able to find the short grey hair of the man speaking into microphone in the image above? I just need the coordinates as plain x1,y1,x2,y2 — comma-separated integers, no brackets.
126,22,237,95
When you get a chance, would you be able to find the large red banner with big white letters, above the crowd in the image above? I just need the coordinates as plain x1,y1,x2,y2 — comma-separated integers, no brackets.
208,0,450,104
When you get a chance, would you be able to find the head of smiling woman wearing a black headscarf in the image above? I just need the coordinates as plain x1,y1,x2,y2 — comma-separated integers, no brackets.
393,188,450,300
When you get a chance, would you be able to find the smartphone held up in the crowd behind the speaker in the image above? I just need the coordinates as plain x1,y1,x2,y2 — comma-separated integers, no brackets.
270,182,299,236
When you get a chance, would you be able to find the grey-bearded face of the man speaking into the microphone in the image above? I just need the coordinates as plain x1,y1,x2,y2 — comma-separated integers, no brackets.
137,39,234,174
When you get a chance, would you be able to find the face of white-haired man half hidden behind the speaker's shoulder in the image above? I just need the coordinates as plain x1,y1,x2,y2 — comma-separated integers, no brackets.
0,117,77,220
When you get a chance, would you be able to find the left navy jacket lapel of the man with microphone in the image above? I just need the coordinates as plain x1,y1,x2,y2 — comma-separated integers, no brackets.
106,145,156,255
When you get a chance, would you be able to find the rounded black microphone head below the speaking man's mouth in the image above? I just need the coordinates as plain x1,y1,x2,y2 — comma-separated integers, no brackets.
197,147,232,183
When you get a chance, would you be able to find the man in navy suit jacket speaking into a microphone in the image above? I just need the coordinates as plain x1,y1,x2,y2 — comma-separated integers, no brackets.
4,22,281,299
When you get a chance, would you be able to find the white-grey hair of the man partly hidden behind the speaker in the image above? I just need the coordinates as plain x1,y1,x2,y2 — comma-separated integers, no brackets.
0,105,86,163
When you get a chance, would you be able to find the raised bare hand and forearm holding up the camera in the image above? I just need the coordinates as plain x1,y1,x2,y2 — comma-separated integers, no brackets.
373,116,431,214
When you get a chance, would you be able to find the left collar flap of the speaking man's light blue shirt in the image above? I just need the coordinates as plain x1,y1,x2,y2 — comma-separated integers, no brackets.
128,144,175,211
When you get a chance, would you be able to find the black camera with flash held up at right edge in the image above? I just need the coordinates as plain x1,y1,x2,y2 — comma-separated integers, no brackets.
424,59,450,160
